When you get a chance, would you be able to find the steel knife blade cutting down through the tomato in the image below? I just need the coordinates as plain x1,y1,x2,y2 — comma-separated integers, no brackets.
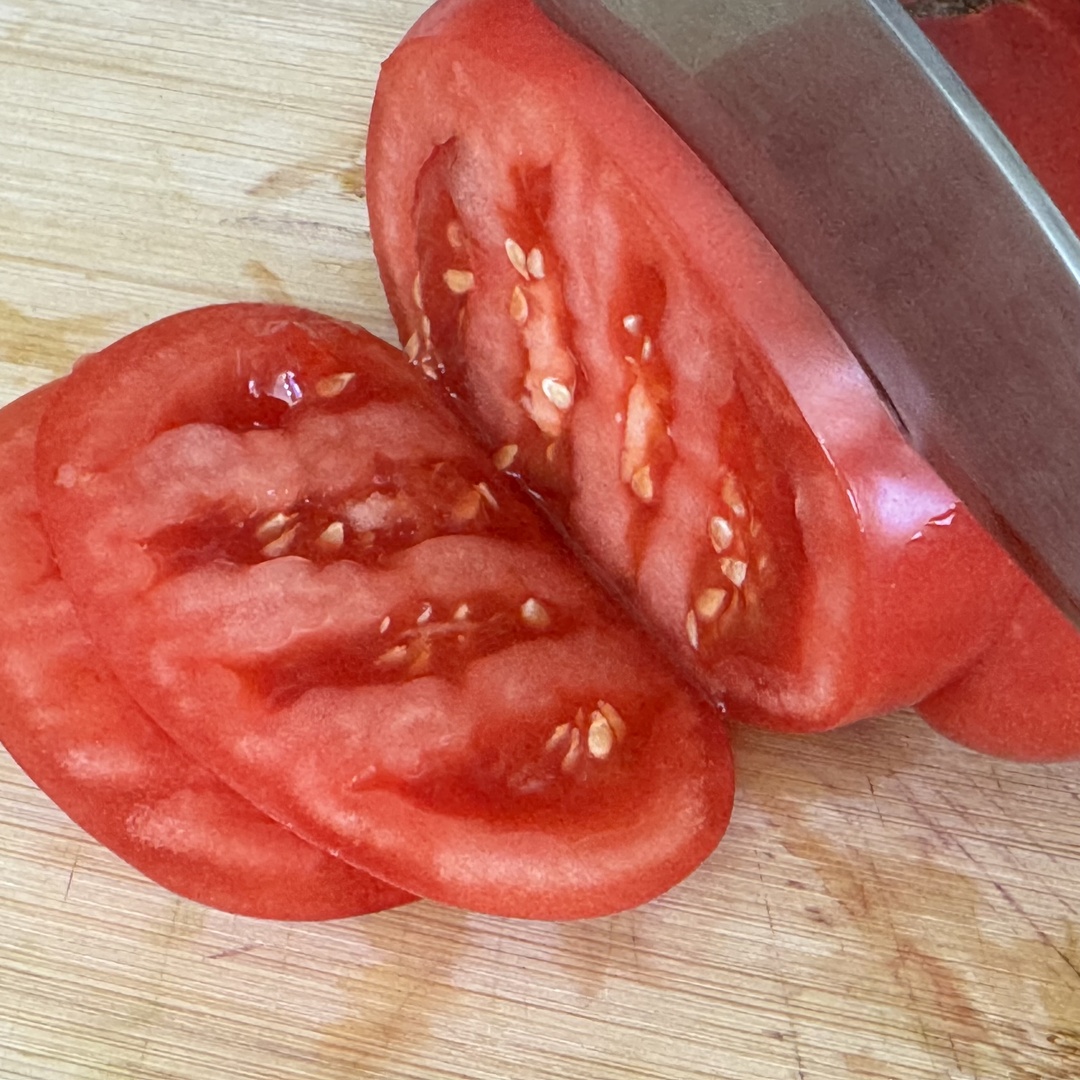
536,0,1080,626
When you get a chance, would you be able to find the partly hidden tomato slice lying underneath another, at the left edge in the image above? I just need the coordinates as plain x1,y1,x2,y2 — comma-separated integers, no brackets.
0,383,411,919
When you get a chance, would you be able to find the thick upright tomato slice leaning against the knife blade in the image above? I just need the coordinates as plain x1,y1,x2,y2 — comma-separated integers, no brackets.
367,0,1004,730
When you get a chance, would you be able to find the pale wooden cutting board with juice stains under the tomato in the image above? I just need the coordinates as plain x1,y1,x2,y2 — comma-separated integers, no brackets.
0,0,1080,1080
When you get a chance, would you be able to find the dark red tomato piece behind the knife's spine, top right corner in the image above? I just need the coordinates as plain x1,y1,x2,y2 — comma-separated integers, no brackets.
910,0,1080,229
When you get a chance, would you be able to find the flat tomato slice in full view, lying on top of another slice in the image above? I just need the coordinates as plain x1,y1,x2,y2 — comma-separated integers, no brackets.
38,305,733,918
